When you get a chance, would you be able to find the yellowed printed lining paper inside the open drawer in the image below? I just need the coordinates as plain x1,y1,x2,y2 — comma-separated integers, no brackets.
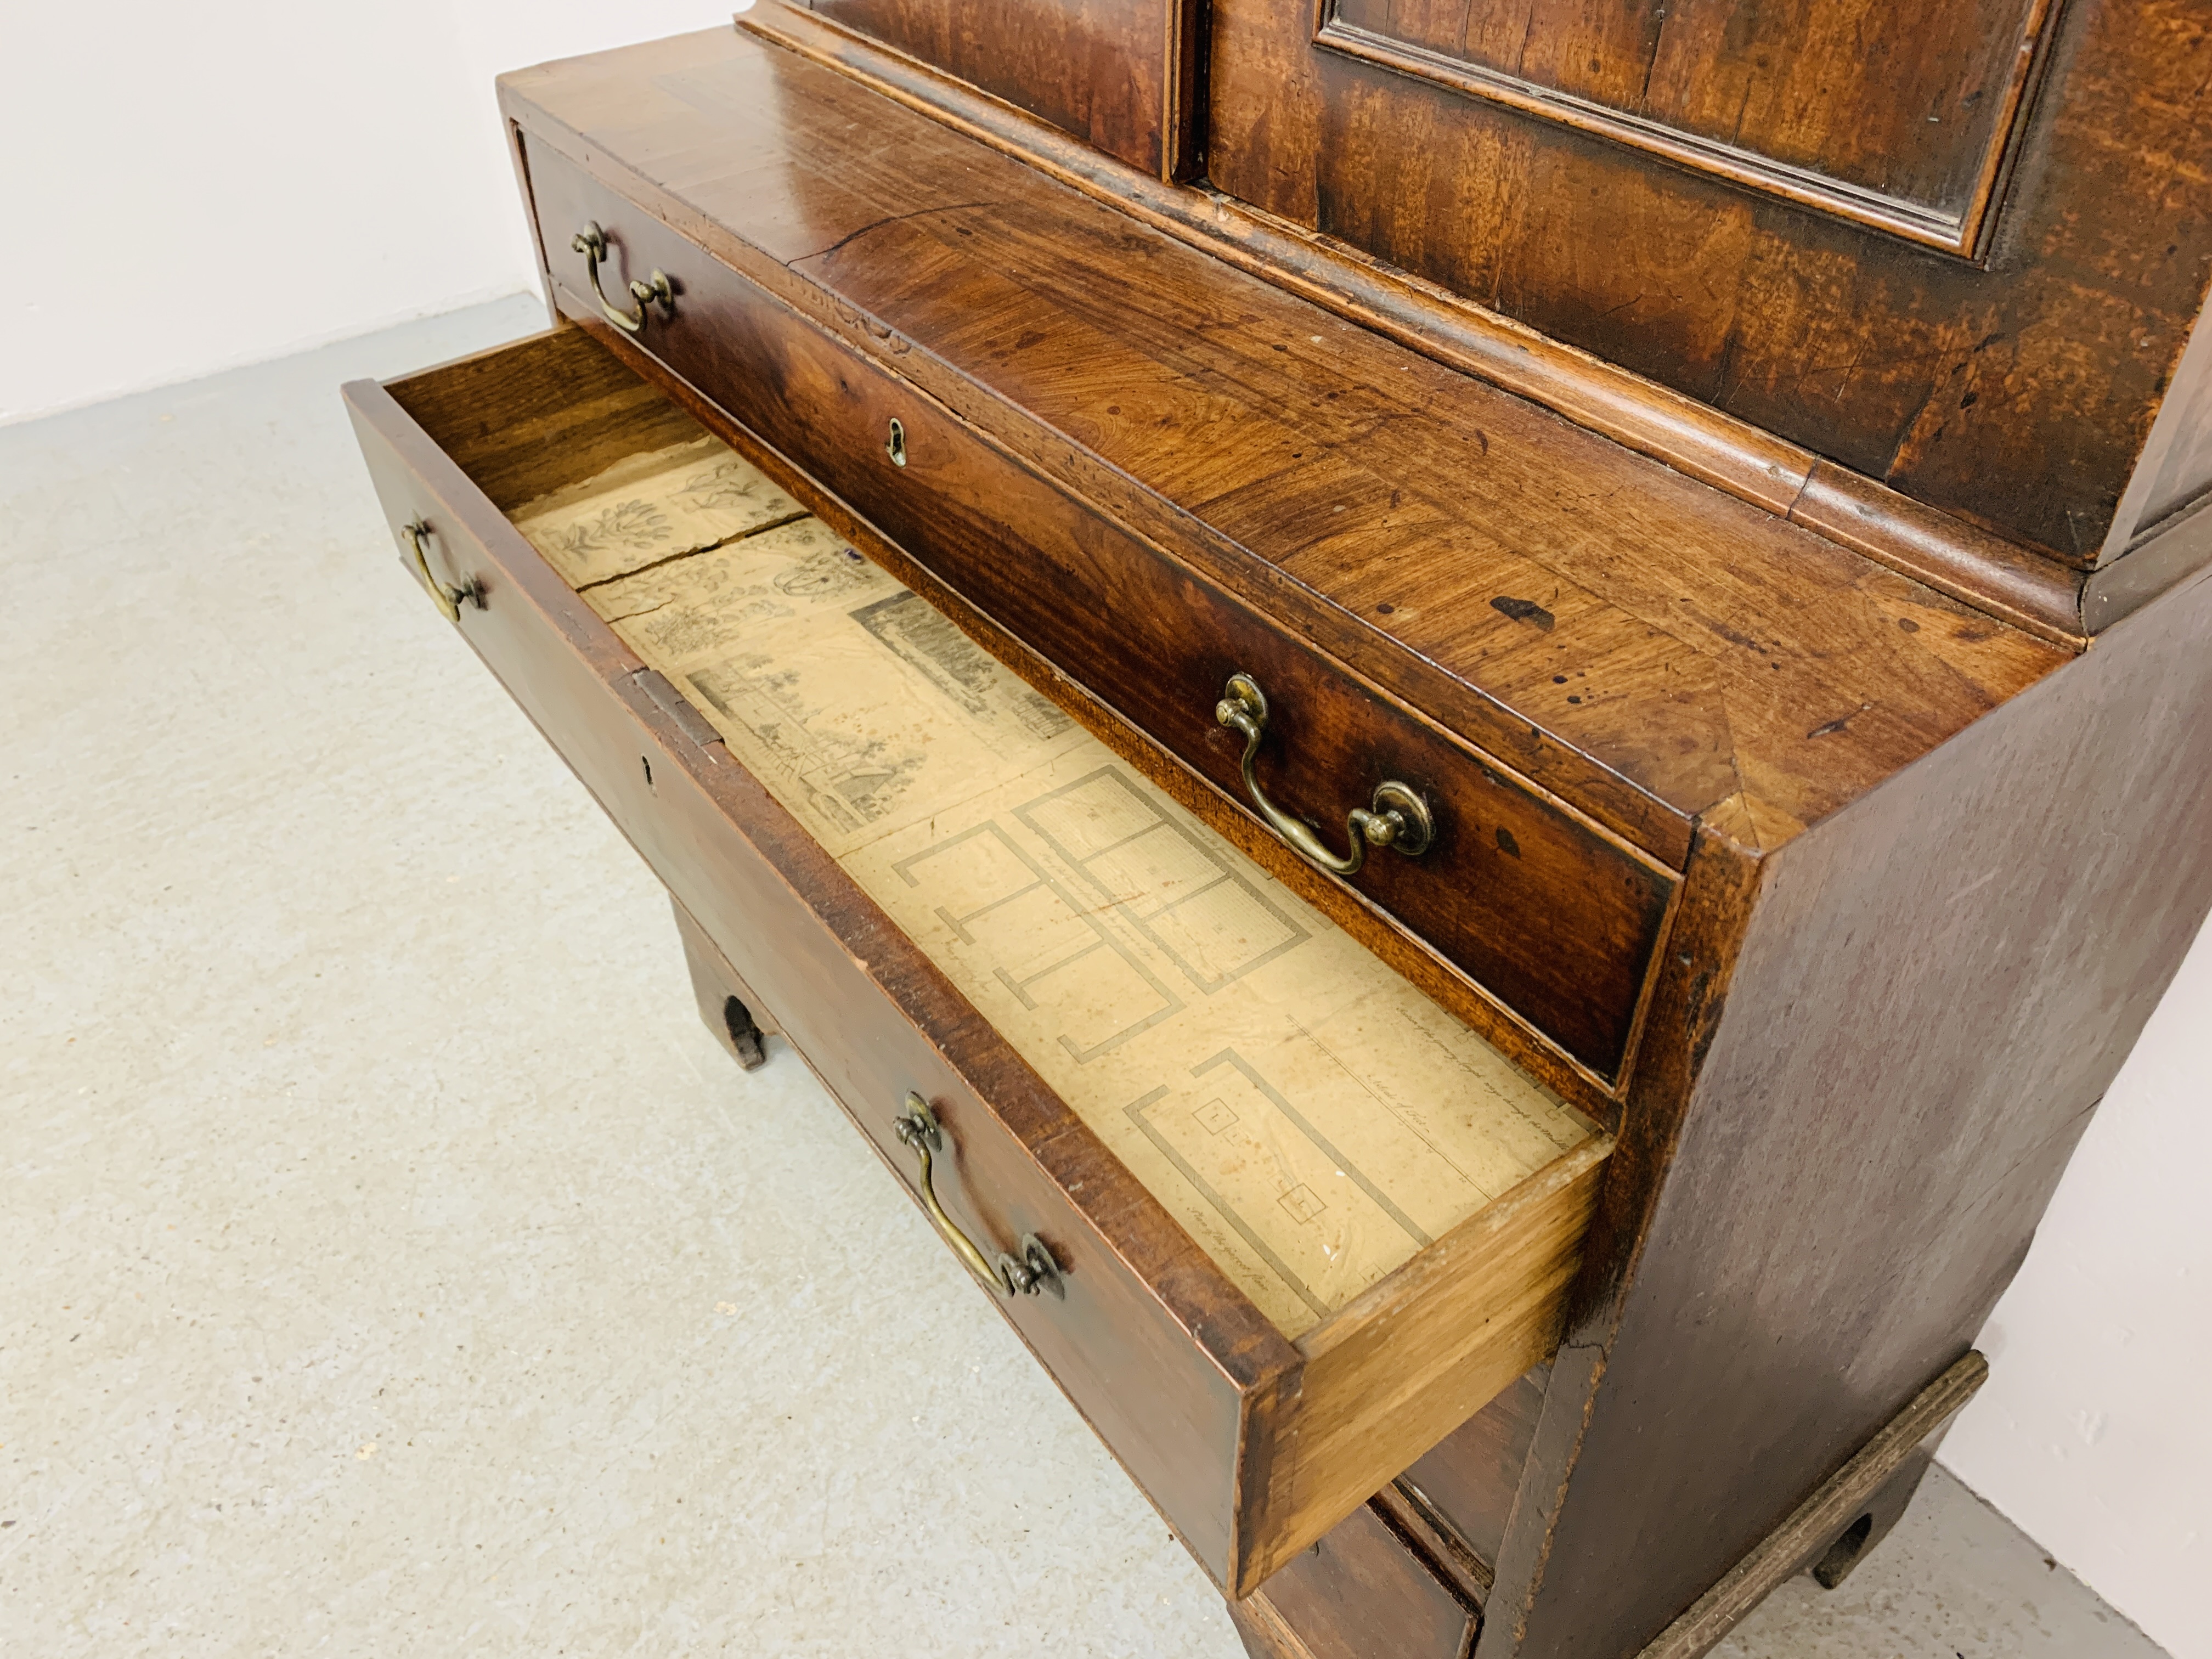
515,440,1593,1336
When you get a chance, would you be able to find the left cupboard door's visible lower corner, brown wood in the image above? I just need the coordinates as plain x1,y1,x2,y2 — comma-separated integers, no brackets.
808,0,1203,179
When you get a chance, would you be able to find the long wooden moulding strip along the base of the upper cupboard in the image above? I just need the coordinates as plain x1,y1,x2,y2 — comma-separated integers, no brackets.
743,0,2106,644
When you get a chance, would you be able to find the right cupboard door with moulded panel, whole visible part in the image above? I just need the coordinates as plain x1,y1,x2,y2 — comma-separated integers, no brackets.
1210,0,2212,566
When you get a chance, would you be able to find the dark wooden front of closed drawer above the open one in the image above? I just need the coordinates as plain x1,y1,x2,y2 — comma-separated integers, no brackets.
529,144,1674,1084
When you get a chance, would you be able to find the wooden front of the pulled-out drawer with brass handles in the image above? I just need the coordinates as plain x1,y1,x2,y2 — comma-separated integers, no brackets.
347,363,1294,1584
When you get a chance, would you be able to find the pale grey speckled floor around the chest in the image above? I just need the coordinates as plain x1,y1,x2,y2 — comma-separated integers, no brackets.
0,301,2157,1659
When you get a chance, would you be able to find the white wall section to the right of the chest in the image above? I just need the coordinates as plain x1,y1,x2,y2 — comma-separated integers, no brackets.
1942,911,2212,1659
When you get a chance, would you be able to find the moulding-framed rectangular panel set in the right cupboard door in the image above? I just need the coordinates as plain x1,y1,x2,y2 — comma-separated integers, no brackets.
1314,0,2051,255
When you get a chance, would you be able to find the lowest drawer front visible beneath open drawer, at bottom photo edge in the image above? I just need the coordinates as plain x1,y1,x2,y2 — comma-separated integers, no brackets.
1230,1509,1475,1659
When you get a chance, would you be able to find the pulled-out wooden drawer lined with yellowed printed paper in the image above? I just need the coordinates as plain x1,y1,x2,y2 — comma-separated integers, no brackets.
345,330,1610,1597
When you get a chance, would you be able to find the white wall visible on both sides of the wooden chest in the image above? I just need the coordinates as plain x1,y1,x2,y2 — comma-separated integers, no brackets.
0,0,2212,1659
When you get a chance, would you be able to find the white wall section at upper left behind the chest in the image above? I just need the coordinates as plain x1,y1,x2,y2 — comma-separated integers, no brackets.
0,0,735,422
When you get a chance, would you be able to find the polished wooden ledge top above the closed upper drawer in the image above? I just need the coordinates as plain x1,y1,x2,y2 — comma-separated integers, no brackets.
504,36,2064,862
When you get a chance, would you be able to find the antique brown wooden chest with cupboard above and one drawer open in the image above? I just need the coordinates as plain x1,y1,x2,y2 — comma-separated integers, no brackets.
347,0,2212,1659
